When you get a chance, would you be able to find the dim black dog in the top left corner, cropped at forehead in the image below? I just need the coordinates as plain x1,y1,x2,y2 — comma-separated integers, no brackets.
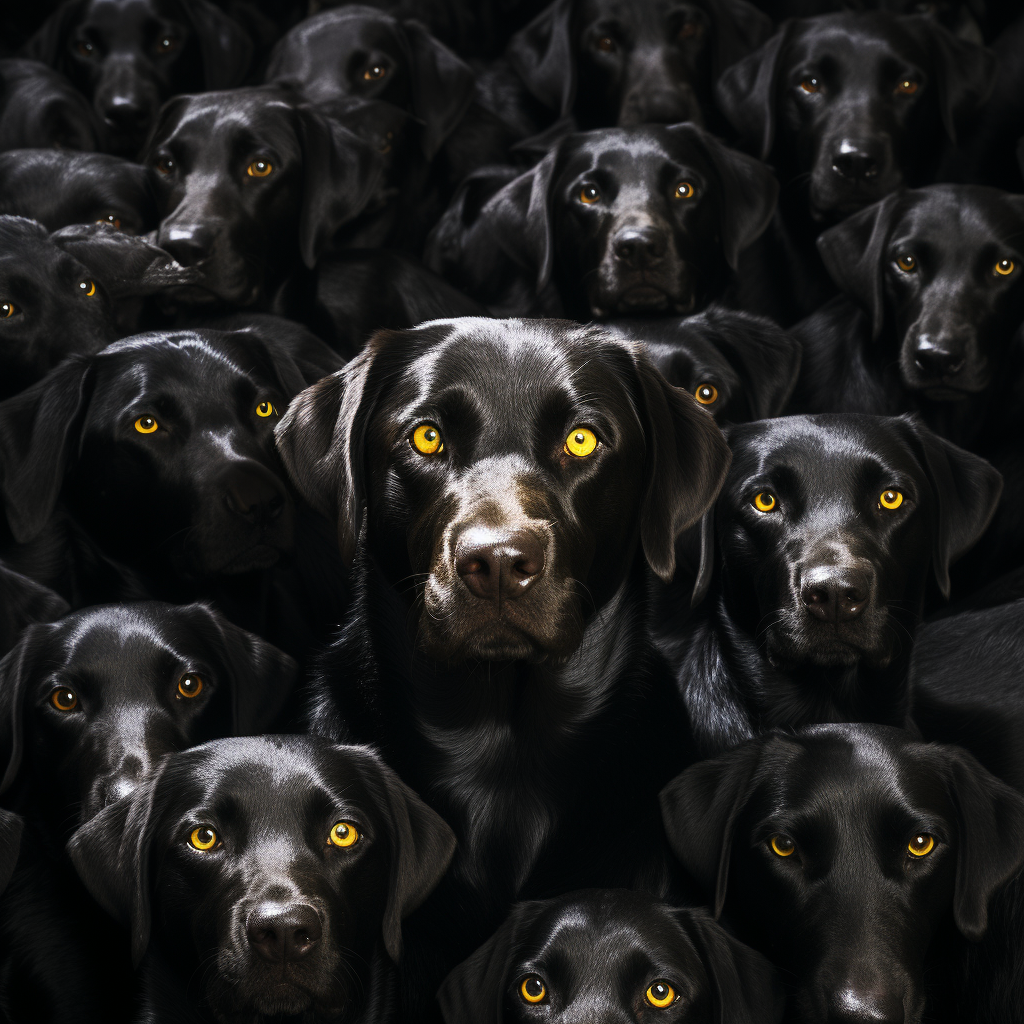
26,0,252,157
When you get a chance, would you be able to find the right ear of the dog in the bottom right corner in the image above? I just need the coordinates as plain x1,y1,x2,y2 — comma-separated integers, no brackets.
945,746,1024,942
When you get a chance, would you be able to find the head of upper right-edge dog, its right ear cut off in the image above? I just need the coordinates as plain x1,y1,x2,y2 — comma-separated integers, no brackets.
819,185,1024,401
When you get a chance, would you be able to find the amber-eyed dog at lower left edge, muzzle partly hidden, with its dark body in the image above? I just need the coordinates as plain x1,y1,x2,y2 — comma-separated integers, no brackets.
0,602,296,1024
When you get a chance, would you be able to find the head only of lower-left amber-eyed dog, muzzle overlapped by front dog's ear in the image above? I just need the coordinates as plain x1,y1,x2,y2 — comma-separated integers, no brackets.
0,602,296,830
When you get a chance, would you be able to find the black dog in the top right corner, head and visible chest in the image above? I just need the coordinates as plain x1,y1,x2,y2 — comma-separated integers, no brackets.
717,11,995,325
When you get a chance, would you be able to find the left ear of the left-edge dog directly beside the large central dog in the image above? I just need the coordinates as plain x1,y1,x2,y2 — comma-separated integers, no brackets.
0,355,92,544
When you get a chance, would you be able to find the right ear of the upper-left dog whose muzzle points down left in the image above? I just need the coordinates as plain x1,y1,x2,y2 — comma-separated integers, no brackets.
295,106,383,268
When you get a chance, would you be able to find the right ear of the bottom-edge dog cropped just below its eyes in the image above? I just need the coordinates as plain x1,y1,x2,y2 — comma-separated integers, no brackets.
676,910,785,1024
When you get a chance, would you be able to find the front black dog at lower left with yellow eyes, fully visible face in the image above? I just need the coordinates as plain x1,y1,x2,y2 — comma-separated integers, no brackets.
70,736,455,1024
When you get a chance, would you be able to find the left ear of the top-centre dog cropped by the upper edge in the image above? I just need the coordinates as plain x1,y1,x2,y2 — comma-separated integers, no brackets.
505,0,577,118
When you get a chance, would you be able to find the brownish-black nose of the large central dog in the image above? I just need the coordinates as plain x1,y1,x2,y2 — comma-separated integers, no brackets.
455,528,544,601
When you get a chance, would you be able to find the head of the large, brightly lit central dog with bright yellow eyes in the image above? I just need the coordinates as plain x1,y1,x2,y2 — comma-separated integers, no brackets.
278,317,725,662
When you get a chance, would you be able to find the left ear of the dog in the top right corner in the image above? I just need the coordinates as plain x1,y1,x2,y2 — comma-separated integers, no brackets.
715,22,793,160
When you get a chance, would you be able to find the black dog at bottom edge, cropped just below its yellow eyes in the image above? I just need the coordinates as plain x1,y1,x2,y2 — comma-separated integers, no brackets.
438,889,782,1024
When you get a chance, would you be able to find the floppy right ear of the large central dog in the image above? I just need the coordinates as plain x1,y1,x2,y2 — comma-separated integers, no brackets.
634,346,732,583
